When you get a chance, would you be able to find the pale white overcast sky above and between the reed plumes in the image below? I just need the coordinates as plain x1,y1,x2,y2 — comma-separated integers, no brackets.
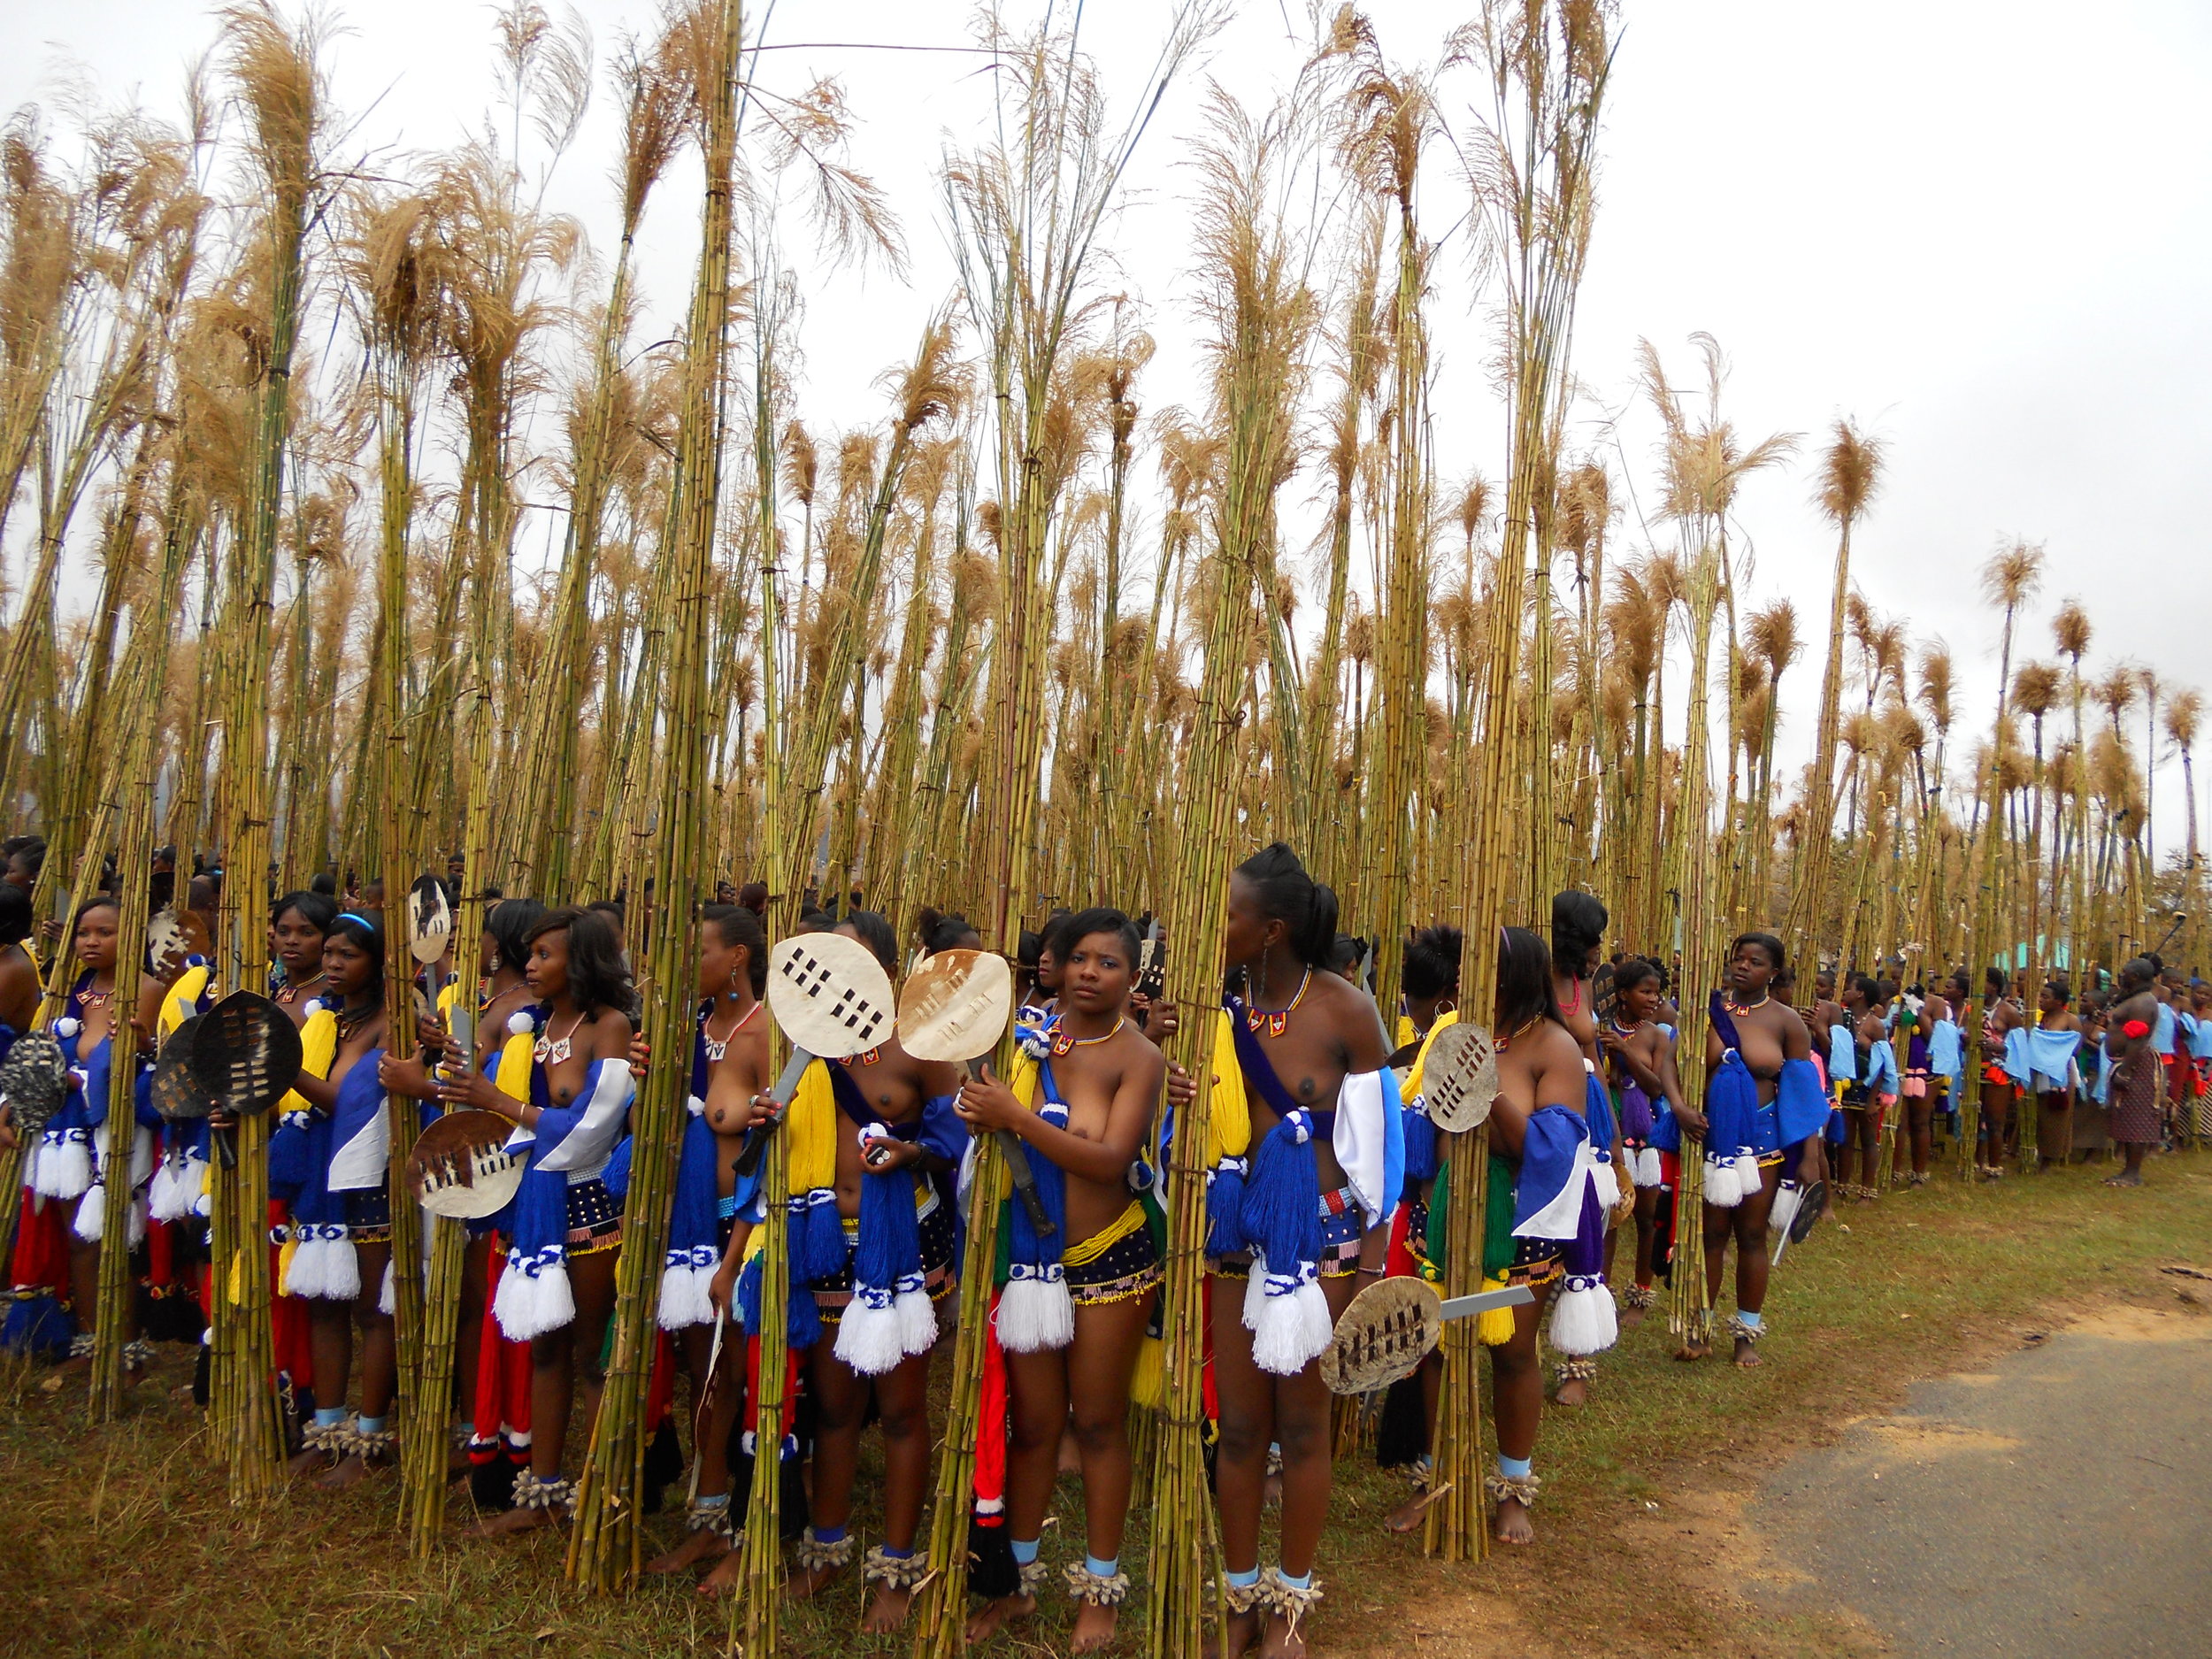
12,0,2212,845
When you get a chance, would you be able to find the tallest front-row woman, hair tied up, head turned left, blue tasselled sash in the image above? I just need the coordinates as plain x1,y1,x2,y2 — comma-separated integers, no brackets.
1206,843,1405,1655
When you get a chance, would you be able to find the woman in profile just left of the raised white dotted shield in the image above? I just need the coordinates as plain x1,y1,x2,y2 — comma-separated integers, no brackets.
646,905,774,1591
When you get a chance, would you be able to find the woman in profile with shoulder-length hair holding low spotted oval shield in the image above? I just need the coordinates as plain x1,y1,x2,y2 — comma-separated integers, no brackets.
438,907,635,1535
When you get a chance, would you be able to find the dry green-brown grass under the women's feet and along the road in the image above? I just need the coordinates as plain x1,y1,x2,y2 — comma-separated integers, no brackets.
0,1155,2212,1659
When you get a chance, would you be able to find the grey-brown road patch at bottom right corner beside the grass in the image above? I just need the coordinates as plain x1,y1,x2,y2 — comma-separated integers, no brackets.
1743,1310,2212,1659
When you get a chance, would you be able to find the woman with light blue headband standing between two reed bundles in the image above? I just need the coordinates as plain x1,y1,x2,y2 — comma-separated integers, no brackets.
270,911,398,1491
